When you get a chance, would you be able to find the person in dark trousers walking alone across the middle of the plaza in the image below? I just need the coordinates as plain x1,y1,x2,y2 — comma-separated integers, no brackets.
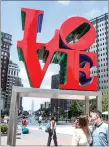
47,117,58,146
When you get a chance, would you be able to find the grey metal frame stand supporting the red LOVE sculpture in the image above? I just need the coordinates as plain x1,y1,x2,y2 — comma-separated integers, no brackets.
7,86,102,146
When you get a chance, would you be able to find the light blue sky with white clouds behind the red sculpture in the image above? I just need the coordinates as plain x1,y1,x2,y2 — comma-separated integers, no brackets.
1,1,108,110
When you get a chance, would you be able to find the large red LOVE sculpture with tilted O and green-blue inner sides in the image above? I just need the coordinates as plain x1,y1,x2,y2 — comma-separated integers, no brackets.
17,8,98,91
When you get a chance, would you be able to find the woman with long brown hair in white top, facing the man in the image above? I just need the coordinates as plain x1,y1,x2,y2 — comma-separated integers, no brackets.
72,116,92,146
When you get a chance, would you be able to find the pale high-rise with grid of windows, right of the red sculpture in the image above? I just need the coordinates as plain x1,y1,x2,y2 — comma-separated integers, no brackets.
89,13,108,91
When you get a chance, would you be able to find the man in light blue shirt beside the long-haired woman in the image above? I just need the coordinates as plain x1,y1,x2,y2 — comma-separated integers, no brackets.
90,110,109,146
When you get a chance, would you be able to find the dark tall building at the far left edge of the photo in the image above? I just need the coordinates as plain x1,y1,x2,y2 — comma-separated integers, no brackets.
1,32,12,111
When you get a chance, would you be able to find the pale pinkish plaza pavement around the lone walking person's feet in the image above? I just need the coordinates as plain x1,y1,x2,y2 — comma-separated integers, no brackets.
1,130,72,147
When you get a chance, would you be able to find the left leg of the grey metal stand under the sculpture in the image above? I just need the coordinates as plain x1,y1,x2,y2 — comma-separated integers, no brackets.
7,90,19,146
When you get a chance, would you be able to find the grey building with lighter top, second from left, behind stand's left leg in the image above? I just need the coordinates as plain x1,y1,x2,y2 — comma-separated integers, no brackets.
4,61,23,112
